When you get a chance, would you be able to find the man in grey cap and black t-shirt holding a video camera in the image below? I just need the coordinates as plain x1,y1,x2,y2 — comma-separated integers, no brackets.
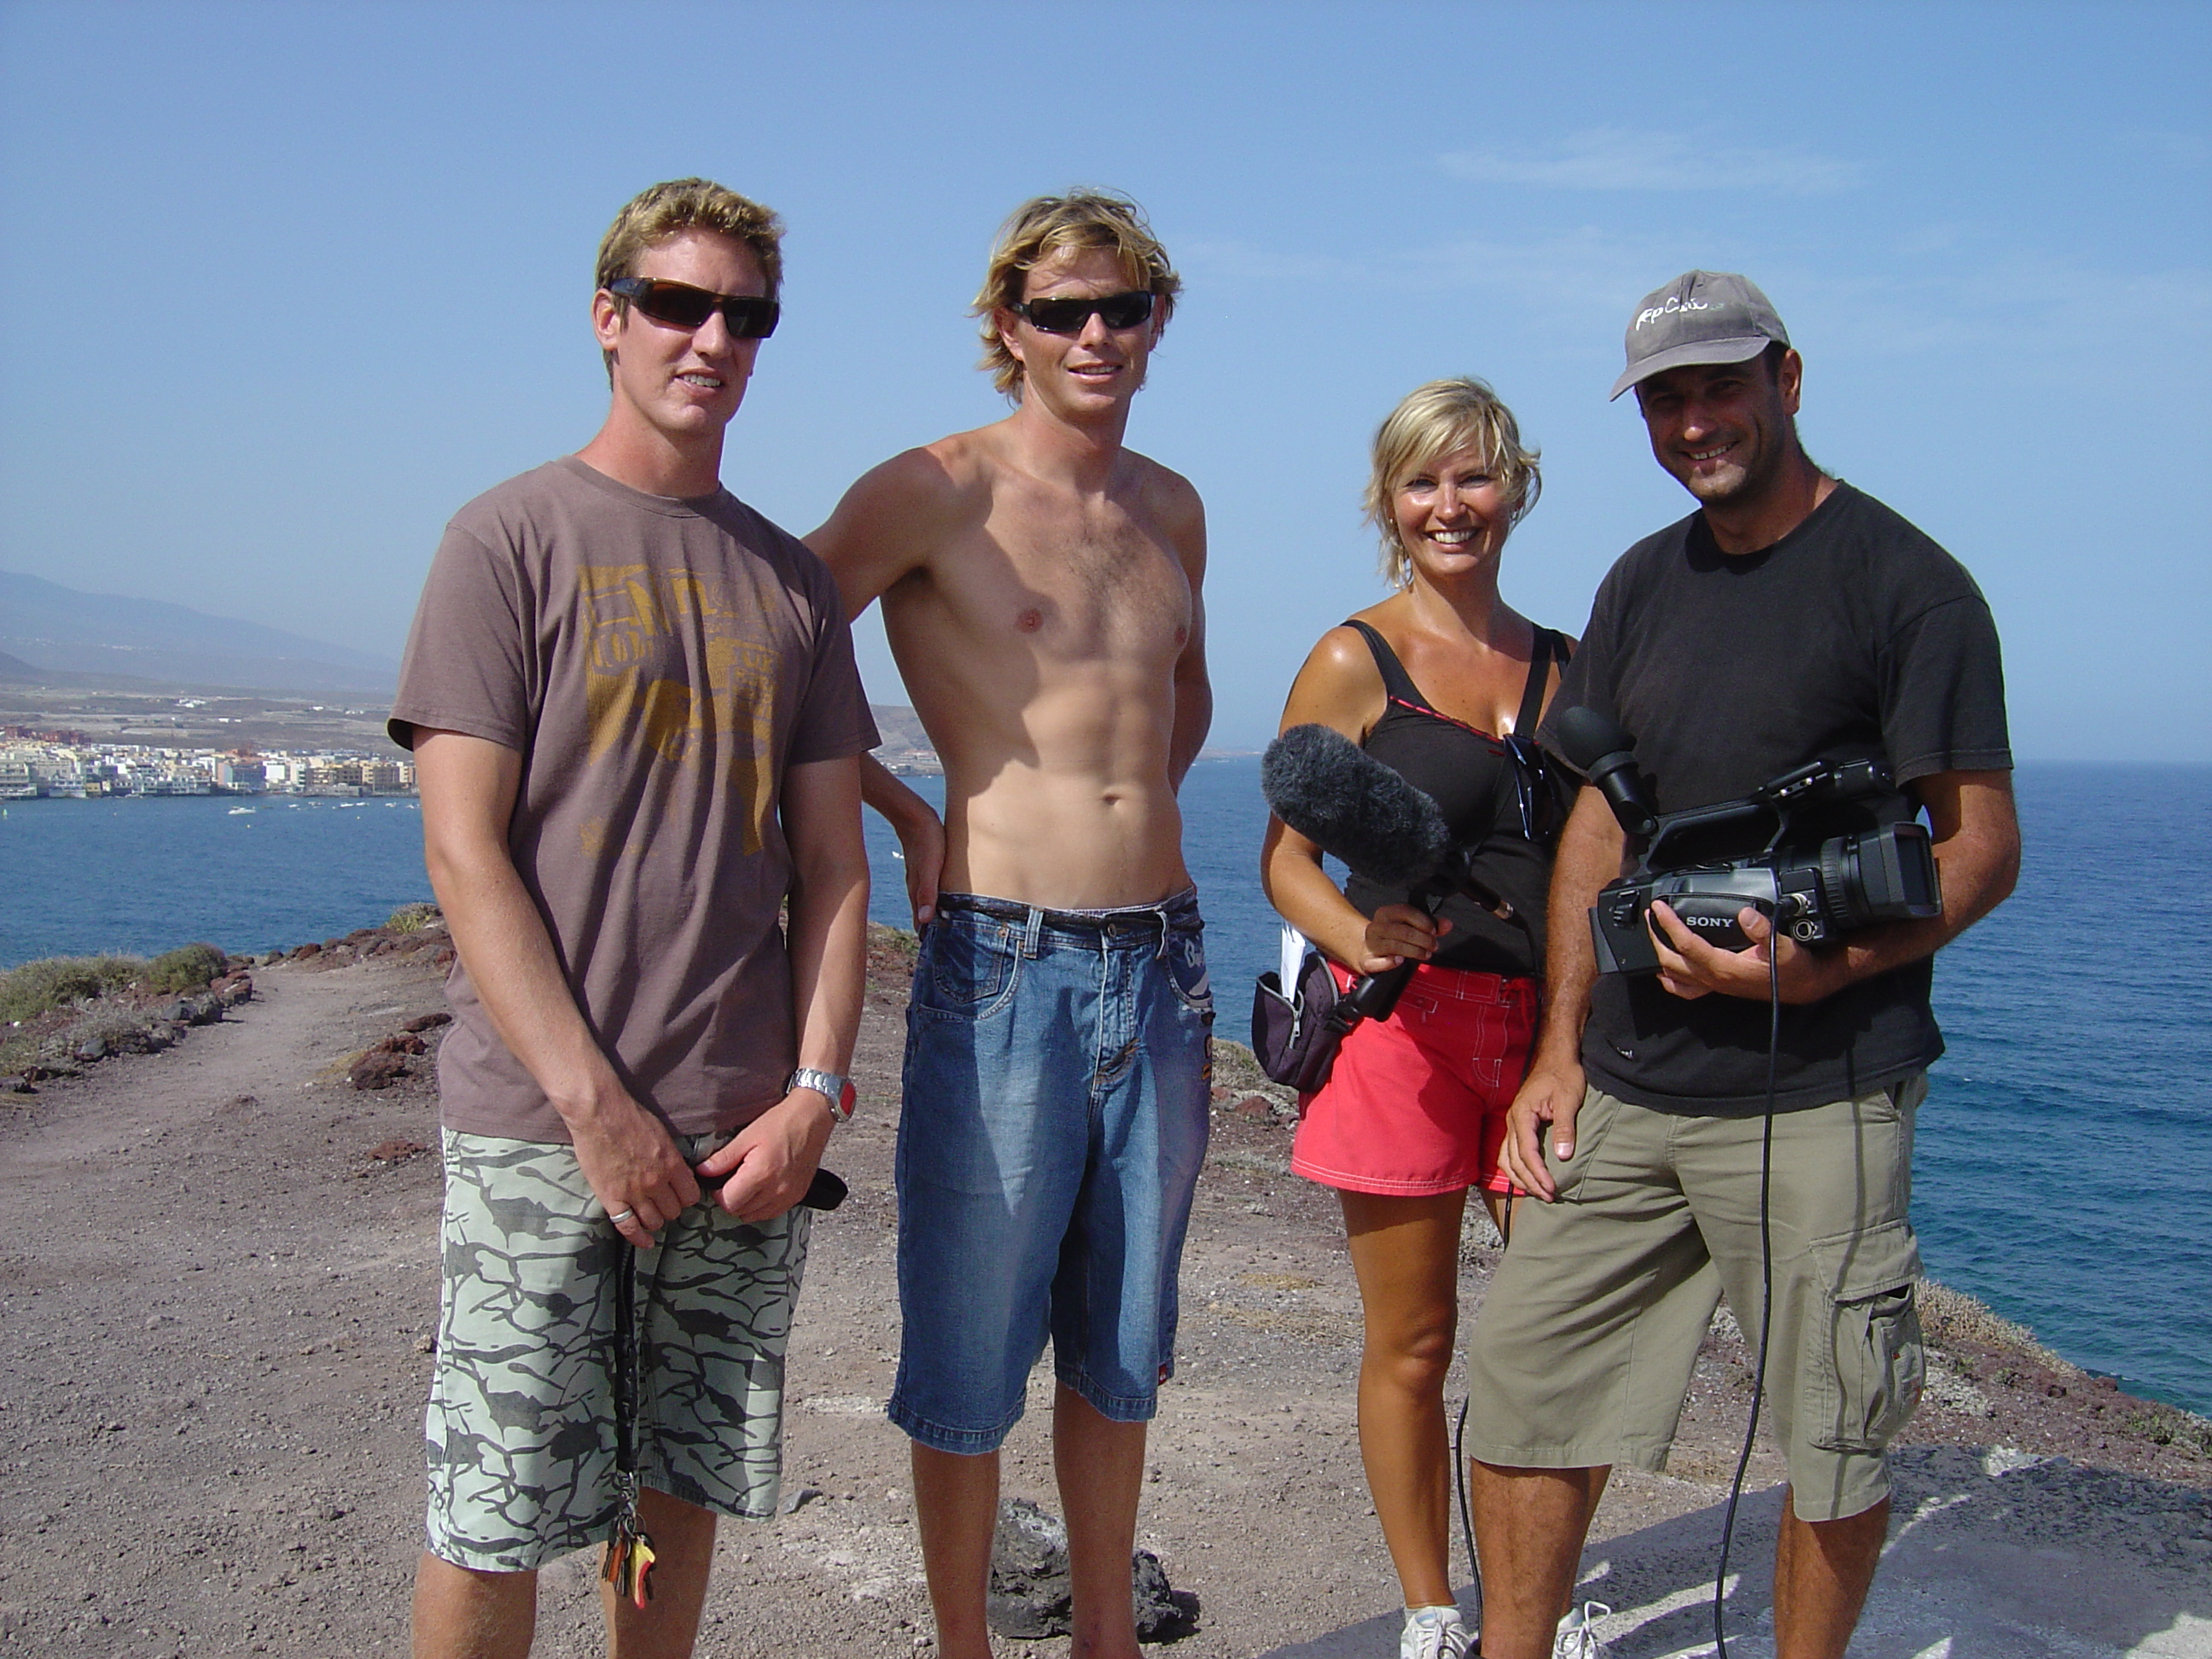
1466,270,2019,1659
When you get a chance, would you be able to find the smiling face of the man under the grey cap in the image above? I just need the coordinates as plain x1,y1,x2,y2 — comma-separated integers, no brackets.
1637,352,1805,507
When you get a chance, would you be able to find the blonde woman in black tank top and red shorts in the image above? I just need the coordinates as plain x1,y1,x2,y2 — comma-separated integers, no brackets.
1260,378,1573,1659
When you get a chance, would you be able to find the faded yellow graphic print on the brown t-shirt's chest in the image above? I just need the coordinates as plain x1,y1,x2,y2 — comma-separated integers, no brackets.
578,564,777,852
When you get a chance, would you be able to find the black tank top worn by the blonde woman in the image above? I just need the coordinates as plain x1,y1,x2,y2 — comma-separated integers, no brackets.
1345,621,1569,978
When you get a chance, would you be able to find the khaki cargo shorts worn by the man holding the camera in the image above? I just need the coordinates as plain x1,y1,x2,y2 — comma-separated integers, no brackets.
1466,1073,1927,1522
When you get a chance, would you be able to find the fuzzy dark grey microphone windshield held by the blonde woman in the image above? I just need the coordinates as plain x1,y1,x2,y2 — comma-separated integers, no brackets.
1259,725,1451,887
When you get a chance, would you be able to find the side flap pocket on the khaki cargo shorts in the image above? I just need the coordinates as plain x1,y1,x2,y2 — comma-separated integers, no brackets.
1801,1221,1927,1451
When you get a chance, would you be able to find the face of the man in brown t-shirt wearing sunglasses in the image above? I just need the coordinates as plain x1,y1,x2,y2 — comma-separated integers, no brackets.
591,230,767,456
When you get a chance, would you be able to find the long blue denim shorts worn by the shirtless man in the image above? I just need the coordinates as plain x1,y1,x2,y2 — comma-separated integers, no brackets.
889,892,1214,1453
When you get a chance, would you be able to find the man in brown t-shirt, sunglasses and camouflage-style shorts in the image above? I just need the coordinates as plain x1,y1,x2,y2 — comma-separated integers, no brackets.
392,179,876,1659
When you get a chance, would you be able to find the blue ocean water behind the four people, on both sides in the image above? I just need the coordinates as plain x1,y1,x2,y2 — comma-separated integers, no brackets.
0,759,2212,1413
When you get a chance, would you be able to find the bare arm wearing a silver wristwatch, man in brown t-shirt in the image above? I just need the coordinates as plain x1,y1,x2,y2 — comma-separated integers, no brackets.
699,759,867,1223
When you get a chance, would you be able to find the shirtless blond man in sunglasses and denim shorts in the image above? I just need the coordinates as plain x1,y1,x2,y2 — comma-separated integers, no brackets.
807,195,1212,1659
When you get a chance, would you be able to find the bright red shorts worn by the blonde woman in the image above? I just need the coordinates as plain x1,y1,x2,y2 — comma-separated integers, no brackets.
1289,963,1537,1196
